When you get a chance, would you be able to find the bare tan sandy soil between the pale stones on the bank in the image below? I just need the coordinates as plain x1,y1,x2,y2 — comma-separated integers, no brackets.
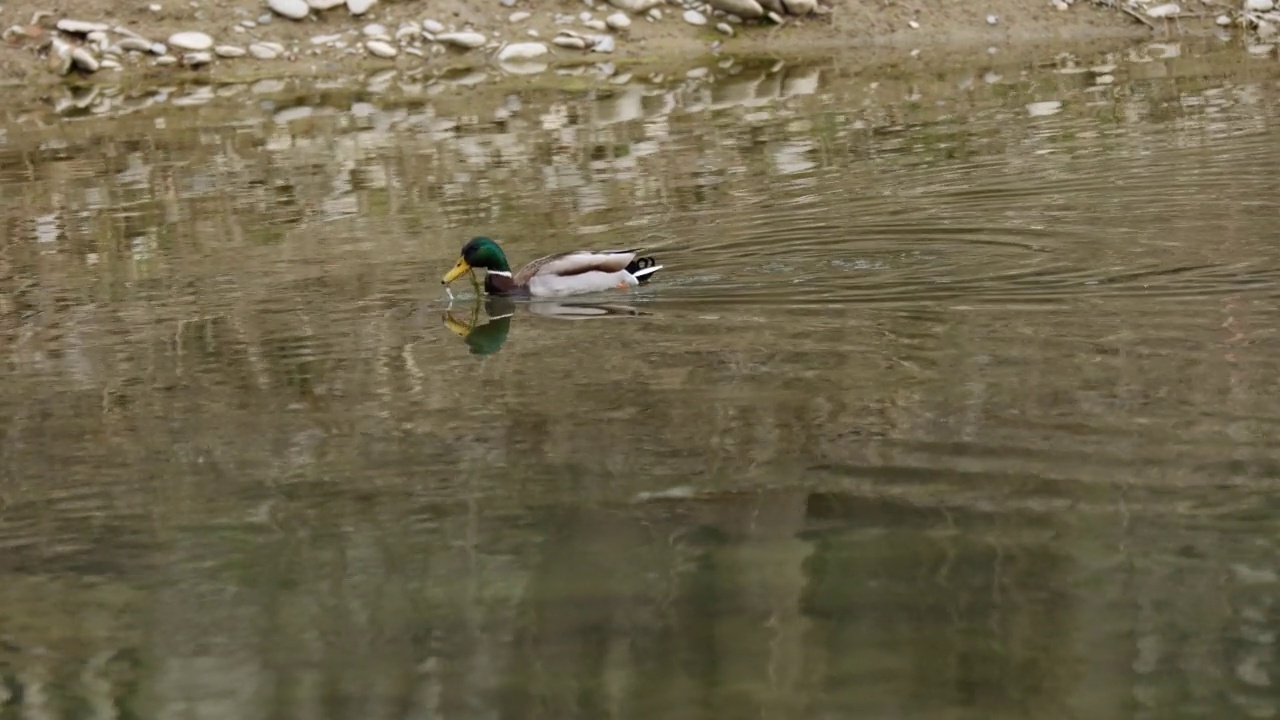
0,0,1187,87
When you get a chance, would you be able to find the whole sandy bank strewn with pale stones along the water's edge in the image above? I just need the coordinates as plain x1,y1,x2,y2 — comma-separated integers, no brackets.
0,0,1264,85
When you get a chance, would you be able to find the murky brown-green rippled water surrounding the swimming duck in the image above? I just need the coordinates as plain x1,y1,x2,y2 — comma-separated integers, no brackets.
0,37,1280,720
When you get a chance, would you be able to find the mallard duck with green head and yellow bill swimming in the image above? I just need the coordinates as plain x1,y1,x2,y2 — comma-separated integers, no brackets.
440,237,662,297
